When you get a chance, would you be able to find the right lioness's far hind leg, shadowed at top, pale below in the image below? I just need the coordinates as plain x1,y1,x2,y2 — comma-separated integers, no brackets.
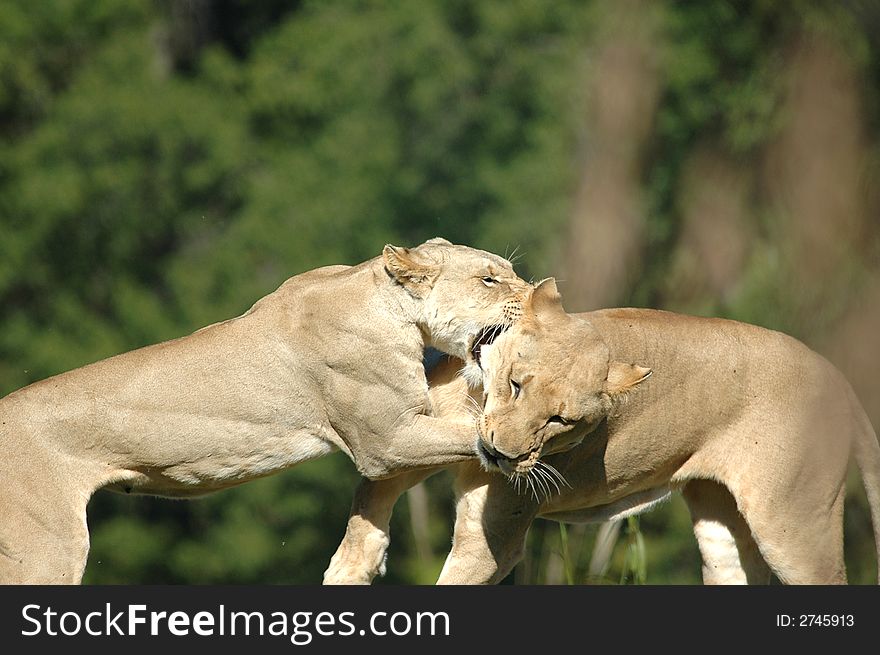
682,480,770,584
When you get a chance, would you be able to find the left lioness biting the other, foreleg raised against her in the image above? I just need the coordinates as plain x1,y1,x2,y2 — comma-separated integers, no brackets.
0,239,530,583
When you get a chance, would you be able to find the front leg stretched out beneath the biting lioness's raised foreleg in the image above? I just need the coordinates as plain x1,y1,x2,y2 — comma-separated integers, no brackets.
324,469,439,585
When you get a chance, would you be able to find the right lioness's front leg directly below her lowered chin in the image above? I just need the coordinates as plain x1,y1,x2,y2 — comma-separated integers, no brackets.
437,463,538,584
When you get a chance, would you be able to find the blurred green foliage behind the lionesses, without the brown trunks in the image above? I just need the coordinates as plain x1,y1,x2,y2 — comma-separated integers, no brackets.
0,0,880,583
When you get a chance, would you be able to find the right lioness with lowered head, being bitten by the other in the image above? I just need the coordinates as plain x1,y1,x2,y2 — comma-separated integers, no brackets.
333,281,880,584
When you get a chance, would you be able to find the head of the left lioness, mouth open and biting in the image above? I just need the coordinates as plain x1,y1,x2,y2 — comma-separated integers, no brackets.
382,239,532,386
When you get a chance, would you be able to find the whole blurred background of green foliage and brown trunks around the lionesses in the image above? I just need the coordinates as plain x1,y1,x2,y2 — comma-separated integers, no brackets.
0,0,880,584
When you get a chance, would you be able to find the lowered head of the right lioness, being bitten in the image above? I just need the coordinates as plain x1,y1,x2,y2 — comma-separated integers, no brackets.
477,279,651,490
